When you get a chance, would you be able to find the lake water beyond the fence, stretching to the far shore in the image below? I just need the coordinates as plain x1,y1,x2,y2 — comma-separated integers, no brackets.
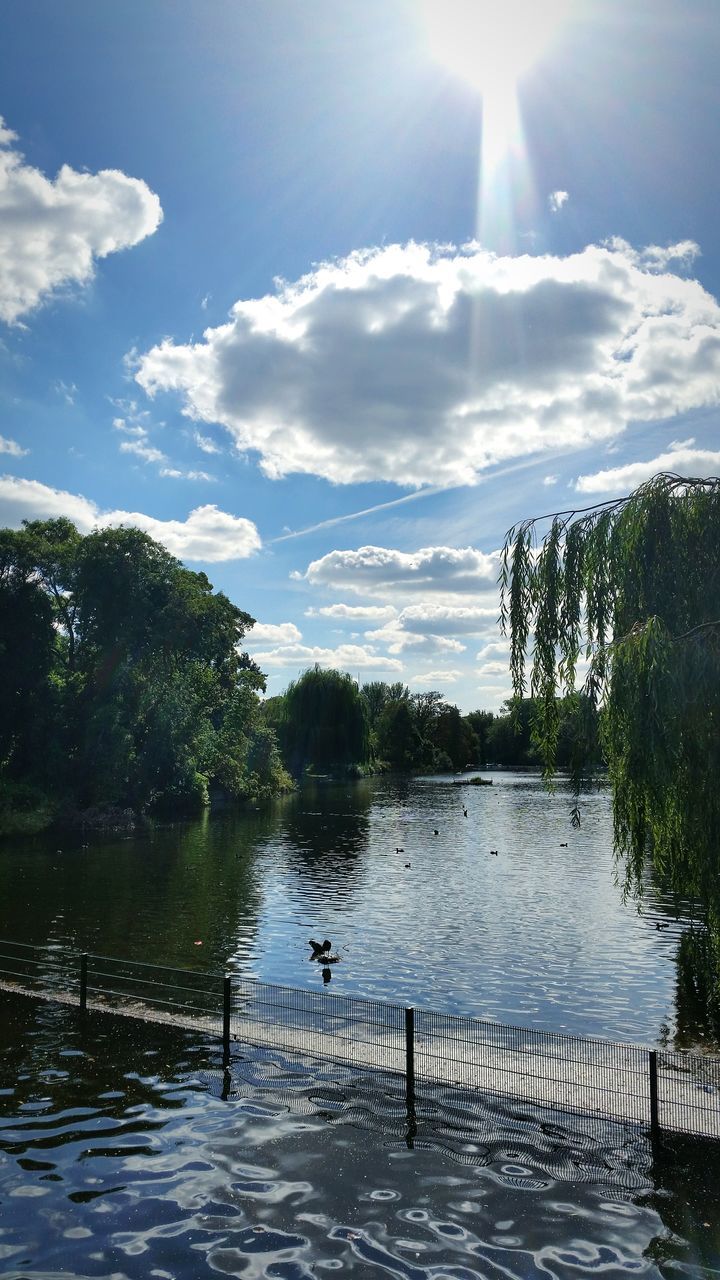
0,773,708,1043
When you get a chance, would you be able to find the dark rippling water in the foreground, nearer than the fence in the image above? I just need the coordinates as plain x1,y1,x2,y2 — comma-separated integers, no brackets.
0,996,720,1280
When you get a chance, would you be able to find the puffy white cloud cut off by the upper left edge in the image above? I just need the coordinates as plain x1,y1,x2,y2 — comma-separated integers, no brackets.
0,116,163,324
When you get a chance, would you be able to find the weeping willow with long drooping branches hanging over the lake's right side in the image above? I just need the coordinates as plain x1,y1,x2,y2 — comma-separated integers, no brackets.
500,474,720,916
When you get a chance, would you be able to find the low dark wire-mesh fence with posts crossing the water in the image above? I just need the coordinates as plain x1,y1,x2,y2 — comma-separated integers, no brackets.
0,941,720,1138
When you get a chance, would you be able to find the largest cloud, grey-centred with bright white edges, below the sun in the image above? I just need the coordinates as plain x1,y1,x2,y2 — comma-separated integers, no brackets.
135,241,720,486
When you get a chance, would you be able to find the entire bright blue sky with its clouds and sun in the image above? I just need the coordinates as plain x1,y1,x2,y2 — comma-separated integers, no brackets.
0,0,720,713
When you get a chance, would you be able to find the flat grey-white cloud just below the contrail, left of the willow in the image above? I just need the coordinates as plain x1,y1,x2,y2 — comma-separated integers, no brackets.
292,547,498,598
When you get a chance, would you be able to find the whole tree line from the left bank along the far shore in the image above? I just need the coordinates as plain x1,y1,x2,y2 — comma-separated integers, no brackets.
0,518,594,831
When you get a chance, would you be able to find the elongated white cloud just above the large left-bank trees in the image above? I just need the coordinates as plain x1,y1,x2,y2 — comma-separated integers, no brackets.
0,475,260,563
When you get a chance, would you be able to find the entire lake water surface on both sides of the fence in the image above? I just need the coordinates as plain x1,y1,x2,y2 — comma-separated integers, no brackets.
0,774,720,1280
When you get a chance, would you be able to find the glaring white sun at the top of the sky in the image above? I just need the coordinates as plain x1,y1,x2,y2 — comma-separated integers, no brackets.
420,0,571,97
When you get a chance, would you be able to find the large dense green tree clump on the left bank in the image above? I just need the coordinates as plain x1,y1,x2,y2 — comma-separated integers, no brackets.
0,520,288,810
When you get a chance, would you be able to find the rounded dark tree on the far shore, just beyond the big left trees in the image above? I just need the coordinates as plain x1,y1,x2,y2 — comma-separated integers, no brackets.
282,666,370,777
